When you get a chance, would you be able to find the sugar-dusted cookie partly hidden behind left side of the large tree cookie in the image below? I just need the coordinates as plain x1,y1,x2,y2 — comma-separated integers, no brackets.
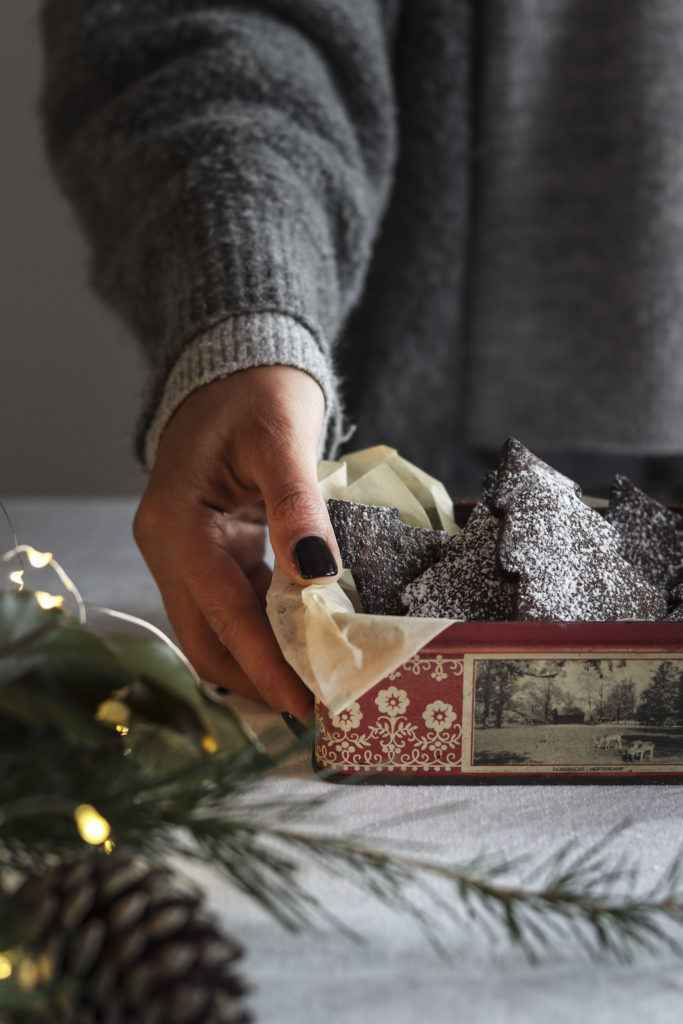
403,512,515,622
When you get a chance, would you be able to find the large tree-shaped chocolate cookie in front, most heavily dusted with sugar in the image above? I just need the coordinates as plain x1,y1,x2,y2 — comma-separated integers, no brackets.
492,438,667,622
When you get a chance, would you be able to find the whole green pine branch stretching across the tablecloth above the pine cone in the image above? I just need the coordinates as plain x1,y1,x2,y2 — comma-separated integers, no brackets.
0,716,683,959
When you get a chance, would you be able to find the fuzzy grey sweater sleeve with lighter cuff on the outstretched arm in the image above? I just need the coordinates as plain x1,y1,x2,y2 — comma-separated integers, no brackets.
37,0,397,465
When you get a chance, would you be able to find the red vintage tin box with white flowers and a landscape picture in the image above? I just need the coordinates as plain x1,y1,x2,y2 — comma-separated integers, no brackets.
313,622,683,783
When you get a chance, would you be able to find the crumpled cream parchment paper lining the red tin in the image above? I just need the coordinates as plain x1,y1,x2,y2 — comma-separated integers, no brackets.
267,445,458,713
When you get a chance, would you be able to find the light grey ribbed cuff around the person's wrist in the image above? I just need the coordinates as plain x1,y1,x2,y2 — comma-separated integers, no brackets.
144,312,343,469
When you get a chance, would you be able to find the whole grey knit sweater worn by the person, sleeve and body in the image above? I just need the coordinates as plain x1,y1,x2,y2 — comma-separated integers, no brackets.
42,0,683,482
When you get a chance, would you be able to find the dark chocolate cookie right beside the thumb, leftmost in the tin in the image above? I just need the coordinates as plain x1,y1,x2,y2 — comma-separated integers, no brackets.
328,498,450,615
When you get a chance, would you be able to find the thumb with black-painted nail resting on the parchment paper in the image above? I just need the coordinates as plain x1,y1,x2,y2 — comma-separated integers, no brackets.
259,443,341,583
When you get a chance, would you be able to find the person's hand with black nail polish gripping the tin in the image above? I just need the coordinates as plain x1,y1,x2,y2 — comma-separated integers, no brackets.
133,367,341,720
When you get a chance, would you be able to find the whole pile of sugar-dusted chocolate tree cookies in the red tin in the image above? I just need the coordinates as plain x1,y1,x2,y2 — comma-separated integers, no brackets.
328,438,683,622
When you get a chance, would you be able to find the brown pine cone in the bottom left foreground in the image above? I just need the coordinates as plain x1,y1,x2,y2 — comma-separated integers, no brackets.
15,853,252,1024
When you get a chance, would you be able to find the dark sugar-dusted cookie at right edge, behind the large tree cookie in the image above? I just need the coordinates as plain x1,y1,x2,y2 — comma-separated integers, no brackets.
605,475,683,594
